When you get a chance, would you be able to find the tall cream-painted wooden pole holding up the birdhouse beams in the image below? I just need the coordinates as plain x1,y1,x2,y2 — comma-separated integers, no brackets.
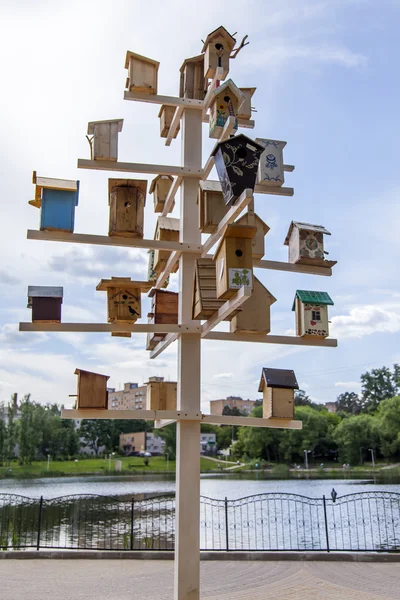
174,109,202,600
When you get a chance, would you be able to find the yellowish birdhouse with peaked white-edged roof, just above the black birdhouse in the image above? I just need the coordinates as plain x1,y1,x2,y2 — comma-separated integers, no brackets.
209,79,245,139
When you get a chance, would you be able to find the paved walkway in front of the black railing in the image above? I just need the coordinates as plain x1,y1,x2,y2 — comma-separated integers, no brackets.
0,559,400,600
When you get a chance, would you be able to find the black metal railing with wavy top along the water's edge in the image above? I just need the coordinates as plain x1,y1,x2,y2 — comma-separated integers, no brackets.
0,492,400,552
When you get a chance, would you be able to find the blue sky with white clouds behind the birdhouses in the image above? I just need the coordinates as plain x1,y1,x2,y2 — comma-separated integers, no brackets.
0,0,400,412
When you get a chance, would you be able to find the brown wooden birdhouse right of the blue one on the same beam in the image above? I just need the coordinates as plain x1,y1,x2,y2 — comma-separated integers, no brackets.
108,179,147,238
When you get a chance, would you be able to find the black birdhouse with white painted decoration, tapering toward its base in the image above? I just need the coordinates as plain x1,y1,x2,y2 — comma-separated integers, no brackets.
211,134,263,205
